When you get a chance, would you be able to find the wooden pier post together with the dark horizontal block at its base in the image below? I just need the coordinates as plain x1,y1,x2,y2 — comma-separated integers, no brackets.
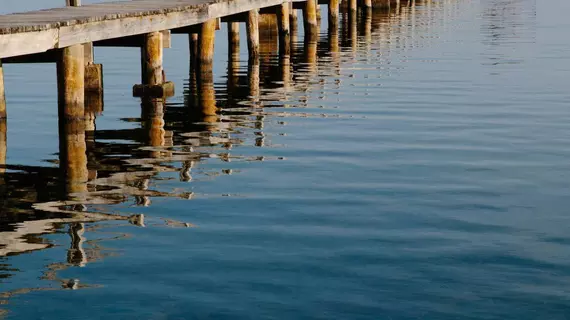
133,31,174,97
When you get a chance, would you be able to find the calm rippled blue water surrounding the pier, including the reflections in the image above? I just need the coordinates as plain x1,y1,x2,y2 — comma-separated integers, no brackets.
0,0,570,319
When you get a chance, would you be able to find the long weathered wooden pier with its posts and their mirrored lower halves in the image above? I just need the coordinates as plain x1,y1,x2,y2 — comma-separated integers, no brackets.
0,0,434,209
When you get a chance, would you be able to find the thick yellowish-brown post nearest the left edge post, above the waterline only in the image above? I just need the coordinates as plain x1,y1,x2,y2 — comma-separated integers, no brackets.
57,44,85,120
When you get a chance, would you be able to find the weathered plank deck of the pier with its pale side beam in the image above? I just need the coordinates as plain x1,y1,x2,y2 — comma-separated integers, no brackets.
0,0,284,58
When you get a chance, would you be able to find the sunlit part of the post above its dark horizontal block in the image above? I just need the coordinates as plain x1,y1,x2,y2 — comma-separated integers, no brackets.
141,31,164,86
